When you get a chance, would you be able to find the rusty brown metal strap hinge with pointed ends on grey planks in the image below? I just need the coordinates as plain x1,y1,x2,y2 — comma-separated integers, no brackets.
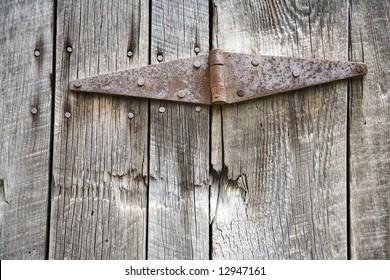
69,49,367,105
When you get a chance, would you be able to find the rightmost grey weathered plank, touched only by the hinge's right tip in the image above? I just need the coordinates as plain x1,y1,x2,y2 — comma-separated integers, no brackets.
349,0,390,259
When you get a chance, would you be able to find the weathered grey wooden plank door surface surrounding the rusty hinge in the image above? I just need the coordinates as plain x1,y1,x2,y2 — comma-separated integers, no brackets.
0,0,390,259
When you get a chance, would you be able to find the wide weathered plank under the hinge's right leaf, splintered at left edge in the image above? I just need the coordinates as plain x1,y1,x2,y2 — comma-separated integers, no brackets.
212,0,348,259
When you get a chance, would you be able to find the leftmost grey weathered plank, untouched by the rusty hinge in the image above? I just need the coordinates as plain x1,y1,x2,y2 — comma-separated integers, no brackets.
0,1,53,259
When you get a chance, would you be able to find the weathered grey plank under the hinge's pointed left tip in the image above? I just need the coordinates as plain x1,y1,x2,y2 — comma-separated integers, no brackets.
50,0,149,259
